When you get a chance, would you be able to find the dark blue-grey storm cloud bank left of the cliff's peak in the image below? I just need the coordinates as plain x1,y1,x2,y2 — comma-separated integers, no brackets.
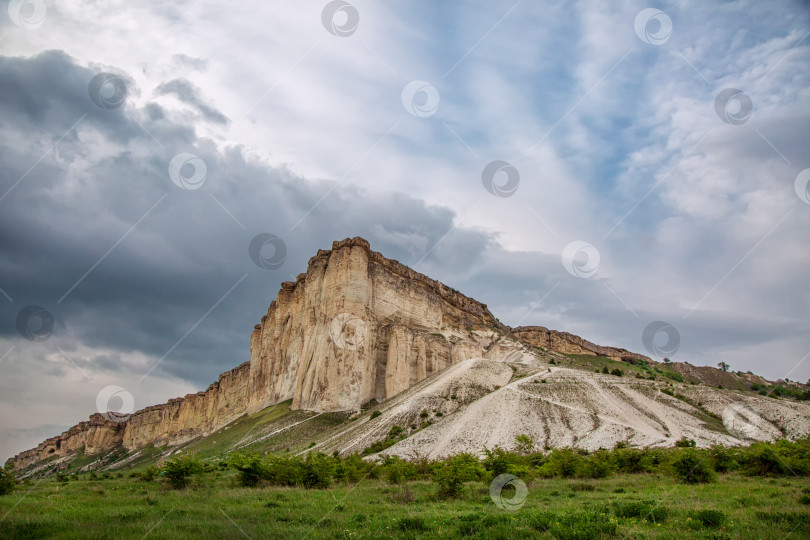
0,52,490,388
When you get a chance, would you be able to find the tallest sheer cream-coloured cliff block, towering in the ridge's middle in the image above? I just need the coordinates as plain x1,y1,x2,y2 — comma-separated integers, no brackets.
248,238,500,412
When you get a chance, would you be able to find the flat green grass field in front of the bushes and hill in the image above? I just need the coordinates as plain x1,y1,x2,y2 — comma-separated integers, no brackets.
0,469,810,540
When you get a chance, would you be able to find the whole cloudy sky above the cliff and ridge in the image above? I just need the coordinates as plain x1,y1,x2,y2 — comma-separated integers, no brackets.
0,0,810,459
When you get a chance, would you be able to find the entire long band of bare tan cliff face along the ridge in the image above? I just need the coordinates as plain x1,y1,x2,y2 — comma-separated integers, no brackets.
7,238,646,468
